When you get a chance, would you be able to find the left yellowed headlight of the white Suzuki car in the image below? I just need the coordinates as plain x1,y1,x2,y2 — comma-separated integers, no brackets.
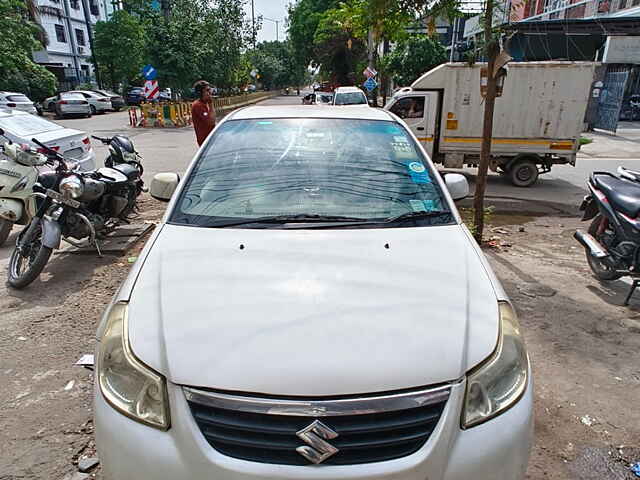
96,303,170,430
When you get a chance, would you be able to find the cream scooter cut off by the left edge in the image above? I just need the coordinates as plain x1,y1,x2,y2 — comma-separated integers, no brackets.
0,129,47,247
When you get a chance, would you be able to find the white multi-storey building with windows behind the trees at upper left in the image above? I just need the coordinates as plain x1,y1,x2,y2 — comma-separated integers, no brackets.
33,0,113,90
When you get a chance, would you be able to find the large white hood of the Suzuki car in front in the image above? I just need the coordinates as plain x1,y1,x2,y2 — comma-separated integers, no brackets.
129,225,498,396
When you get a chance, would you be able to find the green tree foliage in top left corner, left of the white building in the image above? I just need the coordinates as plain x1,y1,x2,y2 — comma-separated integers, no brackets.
0,0,56,101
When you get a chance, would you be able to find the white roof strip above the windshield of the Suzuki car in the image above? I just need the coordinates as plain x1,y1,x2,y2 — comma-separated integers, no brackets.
228,105,396,122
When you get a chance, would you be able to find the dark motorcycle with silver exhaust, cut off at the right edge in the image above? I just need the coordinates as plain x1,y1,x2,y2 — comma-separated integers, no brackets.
574,167,640,305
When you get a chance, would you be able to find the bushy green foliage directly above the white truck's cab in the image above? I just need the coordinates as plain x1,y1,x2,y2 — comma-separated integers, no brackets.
384,35,447,86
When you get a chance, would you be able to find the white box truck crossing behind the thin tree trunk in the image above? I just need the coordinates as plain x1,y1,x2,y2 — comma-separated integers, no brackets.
384,62,597,187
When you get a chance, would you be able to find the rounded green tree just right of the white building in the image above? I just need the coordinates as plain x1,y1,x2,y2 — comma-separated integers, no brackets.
94,10,146,90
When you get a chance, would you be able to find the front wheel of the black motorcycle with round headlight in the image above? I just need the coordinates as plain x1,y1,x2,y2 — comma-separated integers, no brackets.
7,225,52,289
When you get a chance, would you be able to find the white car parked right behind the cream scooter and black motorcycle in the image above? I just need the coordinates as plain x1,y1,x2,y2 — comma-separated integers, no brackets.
0,110,96,171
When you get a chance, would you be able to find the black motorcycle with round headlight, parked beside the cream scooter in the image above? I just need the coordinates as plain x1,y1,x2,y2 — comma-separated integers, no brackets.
8,138,141,289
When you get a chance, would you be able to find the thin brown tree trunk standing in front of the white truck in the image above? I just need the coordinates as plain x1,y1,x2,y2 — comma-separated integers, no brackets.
473,0,500,244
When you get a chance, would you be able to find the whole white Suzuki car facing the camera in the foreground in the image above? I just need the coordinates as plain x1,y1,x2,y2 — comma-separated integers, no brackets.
94,105,533,480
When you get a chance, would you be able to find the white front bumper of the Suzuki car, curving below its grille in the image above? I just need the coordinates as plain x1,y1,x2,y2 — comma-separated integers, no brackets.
94,381,533,480
